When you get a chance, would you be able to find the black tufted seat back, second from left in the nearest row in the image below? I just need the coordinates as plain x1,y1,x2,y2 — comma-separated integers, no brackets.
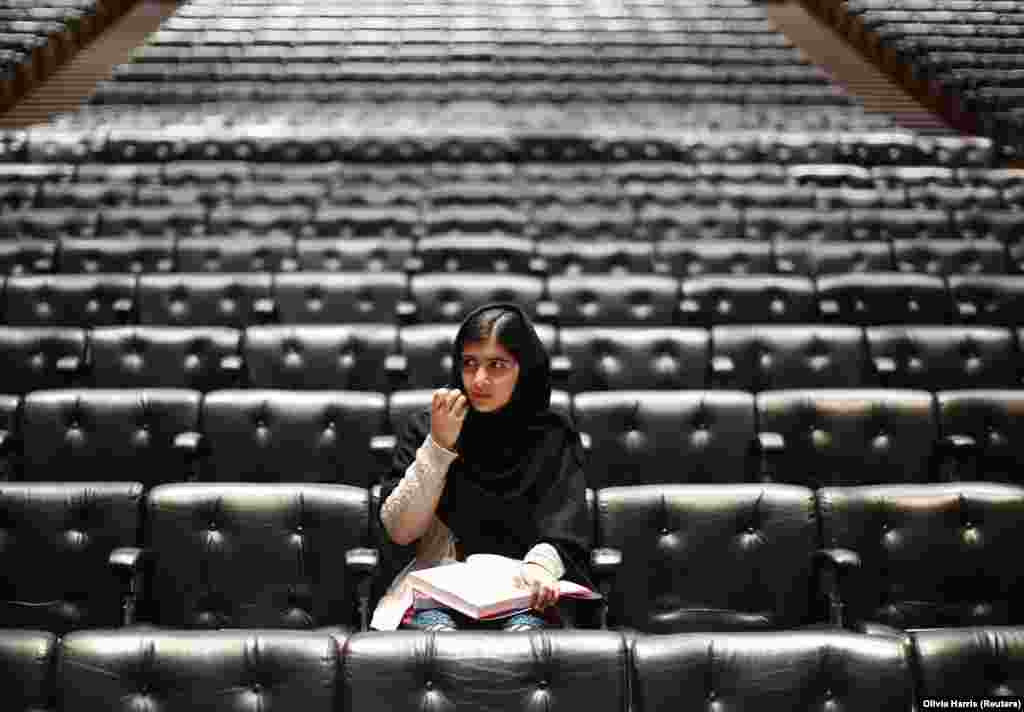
56,630,341,712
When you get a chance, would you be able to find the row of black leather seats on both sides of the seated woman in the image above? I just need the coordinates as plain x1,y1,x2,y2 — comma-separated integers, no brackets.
0,481,1024,631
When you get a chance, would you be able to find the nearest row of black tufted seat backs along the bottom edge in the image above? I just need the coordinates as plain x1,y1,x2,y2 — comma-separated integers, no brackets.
0,626,1024,712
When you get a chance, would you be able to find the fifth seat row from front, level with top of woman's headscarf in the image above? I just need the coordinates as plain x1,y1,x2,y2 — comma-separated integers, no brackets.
0,271,1024,328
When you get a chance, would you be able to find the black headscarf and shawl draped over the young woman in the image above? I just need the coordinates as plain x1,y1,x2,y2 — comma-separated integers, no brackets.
382,303,590,583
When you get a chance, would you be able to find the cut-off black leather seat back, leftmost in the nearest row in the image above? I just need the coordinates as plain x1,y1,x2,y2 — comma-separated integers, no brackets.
0,630,57,712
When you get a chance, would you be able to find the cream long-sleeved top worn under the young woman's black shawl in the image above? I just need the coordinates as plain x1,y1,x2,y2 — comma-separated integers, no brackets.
371,435,565,630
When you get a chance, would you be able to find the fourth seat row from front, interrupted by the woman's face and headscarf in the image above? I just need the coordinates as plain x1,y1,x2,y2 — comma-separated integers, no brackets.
6,324,1024,394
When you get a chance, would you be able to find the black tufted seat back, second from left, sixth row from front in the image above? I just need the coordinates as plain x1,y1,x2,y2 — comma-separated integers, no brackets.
57,237,175,275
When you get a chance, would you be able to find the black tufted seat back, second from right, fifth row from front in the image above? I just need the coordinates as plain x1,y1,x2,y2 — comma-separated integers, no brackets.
818,273,950,326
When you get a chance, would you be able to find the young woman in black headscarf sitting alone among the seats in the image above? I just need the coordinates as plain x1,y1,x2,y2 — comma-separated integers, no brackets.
381,303,590,630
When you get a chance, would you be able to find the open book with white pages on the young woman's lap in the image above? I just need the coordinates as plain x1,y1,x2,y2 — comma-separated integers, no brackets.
409,554,601,620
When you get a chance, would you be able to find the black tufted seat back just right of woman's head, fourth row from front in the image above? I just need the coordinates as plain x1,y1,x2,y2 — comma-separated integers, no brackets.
552,327,709,393
